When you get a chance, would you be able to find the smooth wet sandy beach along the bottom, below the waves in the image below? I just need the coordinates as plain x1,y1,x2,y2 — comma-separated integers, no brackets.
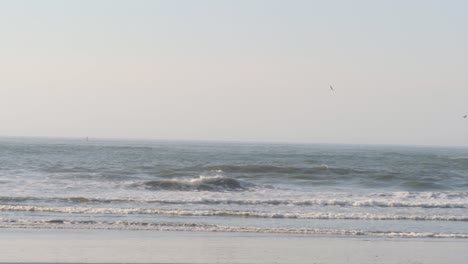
0,229,468,264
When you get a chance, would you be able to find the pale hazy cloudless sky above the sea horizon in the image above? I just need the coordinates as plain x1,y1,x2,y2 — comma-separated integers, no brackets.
0,0,468,146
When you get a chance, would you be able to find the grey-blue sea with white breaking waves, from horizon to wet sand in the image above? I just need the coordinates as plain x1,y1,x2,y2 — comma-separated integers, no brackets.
0,138,468,239
